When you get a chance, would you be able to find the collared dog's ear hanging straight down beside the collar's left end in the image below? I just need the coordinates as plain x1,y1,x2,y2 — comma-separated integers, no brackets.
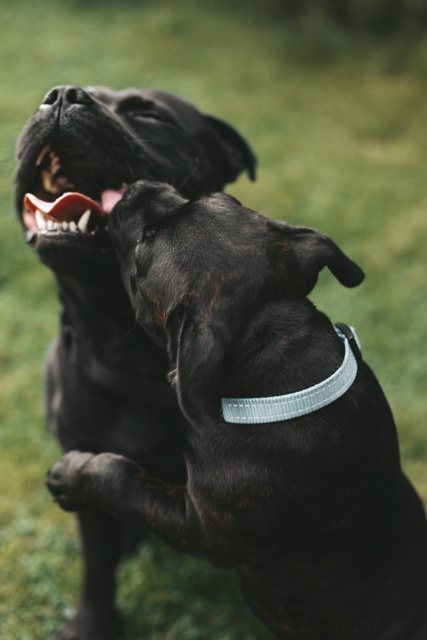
166,307,225,429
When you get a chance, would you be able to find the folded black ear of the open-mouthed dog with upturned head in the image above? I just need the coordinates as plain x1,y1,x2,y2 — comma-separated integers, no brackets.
205,116,256,181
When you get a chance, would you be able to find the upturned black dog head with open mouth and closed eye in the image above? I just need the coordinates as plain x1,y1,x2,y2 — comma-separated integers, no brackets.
15,86,255,276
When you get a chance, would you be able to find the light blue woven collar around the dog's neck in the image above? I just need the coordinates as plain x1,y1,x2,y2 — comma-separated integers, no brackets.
221,322,360,424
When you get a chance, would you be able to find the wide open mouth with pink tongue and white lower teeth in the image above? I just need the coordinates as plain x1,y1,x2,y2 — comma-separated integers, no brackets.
22,145,126,240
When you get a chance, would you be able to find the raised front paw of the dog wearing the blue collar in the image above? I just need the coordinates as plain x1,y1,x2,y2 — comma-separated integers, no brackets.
46,451,94,511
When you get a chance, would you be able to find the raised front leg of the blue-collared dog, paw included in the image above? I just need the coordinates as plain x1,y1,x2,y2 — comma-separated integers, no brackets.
47,451,216,555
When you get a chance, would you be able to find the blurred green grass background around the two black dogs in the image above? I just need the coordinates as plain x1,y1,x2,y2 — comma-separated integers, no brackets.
0,0,427,640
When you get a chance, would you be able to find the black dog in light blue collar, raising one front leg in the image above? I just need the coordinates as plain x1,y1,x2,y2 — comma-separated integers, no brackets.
48,183,427,640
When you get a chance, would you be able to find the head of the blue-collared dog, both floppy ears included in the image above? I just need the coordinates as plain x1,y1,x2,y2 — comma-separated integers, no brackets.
110,182,364,423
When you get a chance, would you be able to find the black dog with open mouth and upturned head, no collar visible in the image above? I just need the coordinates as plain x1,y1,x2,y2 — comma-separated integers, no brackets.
16,86,255,640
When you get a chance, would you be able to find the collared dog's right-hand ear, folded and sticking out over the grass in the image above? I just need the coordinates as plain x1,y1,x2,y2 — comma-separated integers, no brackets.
273,223,365,295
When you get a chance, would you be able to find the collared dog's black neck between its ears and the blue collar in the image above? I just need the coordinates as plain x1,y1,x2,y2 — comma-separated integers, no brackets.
222,299,350,408
